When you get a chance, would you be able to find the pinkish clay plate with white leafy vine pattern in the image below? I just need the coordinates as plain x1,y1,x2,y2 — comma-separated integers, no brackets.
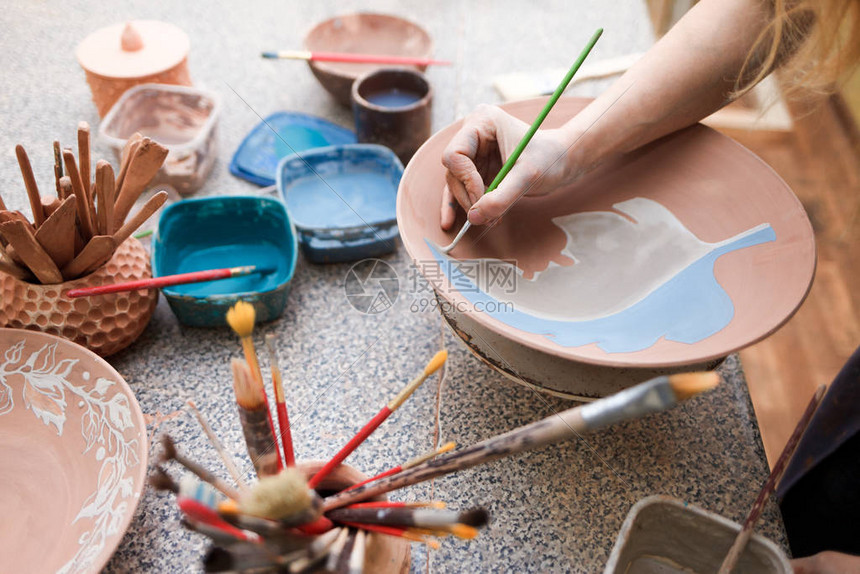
0,329,147,574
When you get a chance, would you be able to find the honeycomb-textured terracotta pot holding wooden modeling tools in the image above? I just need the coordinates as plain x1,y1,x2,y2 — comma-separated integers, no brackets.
0,238,158,357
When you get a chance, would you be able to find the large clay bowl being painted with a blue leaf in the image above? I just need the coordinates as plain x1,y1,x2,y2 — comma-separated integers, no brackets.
397,98,815,397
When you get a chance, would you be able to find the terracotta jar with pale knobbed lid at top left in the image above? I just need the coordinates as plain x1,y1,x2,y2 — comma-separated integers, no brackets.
75,20,191,118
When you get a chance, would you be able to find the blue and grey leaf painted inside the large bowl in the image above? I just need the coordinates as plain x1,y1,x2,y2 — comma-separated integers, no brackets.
434,198,776,353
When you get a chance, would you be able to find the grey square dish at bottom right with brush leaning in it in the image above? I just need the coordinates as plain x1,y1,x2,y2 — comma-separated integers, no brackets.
603,495,792,574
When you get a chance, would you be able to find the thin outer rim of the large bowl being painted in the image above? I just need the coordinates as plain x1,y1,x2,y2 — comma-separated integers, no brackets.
397,96,818,368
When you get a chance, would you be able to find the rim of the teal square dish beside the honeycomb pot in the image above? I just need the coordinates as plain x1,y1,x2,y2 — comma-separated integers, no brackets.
151,195,299,303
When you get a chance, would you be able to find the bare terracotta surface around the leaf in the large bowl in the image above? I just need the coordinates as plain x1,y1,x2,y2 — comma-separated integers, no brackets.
397,98,815,367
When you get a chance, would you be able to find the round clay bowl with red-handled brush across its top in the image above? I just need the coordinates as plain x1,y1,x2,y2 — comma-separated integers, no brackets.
304,13,433,106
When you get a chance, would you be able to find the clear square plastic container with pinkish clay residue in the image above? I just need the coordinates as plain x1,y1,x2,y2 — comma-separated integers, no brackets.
99,84,221,195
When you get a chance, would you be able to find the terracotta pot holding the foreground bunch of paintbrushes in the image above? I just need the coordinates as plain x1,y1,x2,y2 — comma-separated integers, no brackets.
296,460,410,574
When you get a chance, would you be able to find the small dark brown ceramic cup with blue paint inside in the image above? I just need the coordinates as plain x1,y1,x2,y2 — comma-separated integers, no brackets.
352,68,433,165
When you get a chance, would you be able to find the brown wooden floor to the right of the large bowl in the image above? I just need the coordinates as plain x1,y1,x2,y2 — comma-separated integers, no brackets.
721,98,860,465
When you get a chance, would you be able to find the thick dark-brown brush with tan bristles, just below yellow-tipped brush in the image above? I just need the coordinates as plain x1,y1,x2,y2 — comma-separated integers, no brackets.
230,359,282,477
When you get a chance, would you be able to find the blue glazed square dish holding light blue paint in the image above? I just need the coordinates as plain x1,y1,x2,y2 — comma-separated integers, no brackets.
277,144,403,263
